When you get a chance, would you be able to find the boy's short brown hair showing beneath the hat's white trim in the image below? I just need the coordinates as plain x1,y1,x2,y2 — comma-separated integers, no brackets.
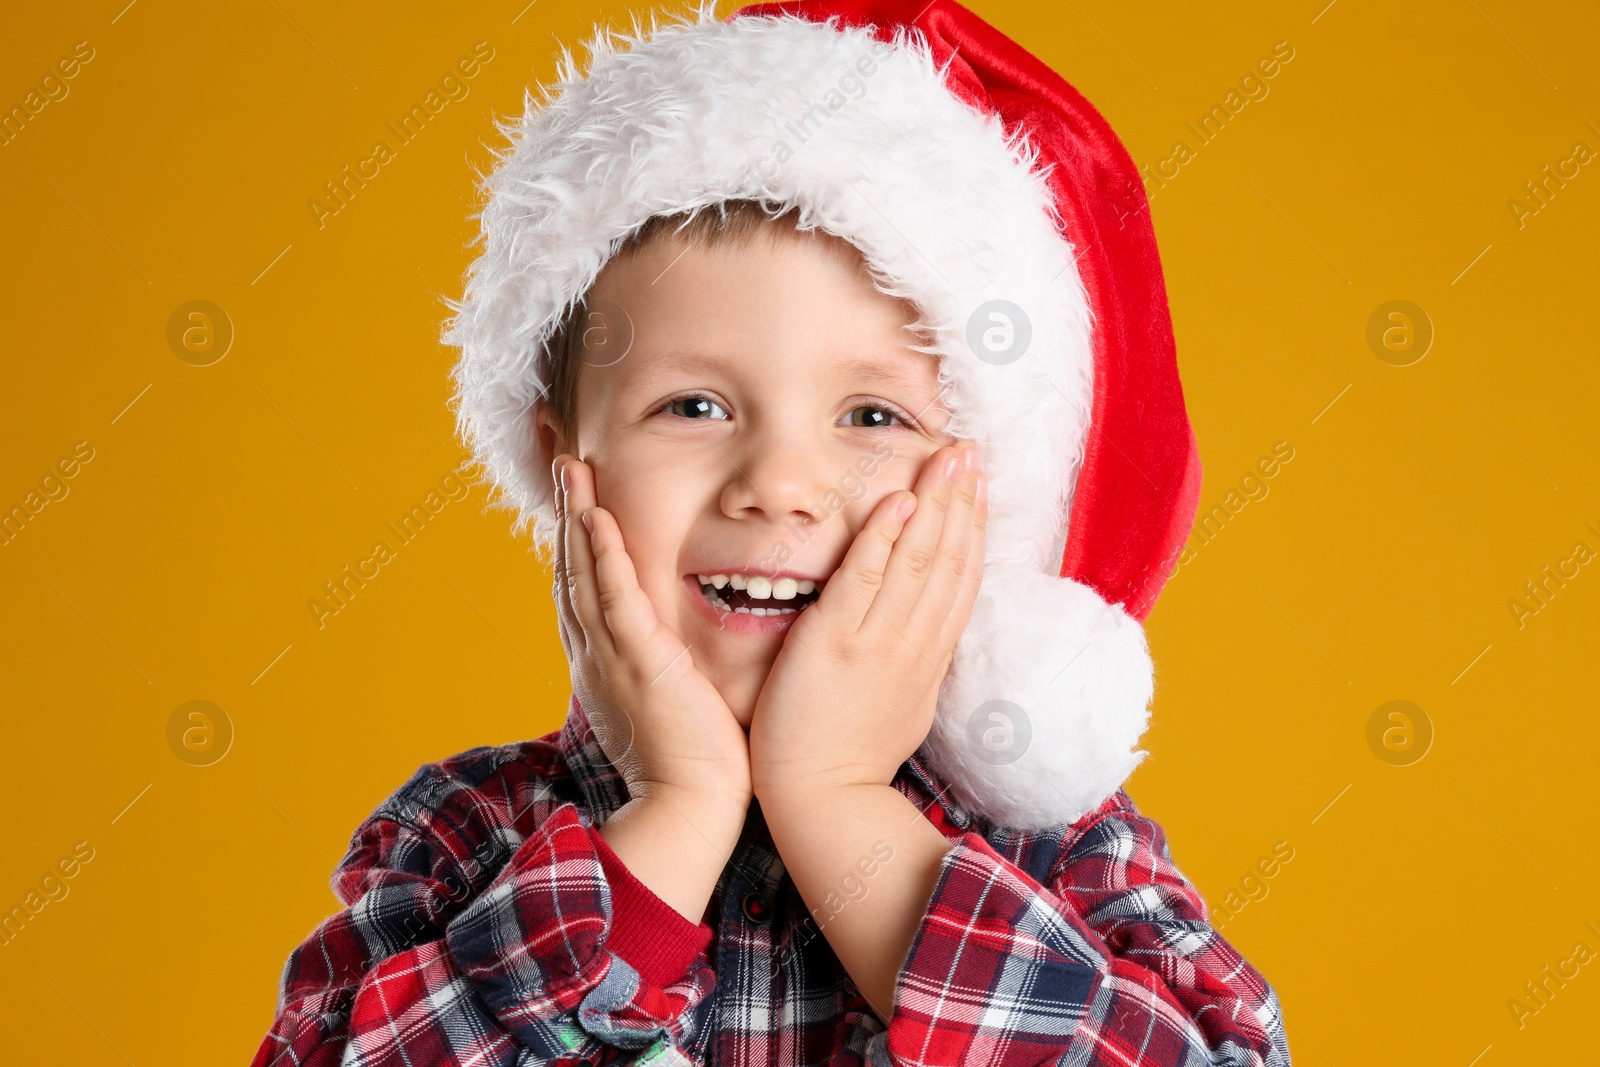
544,200,800,437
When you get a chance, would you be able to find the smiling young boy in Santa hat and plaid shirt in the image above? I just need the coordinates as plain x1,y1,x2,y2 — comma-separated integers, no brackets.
254,0,1290,1067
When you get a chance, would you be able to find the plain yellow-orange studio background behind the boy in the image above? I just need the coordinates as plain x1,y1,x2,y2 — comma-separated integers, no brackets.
0,0,1600,1067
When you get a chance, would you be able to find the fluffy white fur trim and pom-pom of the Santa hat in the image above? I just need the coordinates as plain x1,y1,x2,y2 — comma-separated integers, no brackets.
443,5,1203,829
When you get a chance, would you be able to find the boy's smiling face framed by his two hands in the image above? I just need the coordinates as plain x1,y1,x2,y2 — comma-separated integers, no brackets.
538,223,954,728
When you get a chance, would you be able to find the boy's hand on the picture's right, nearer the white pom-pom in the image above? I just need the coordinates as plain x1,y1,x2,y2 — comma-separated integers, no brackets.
750,442,989,797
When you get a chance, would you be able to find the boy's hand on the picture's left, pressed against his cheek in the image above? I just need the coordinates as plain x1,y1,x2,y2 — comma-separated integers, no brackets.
552,453,750,801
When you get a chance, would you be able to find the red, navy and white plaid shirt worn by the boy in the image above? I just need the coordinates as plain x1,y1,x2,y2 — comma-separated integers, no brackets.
253,699,1290,1067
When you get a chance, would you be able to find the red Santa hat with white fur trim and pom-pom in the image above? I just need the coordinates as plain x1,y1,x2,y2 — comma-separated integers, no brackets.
445,0,1200,829
